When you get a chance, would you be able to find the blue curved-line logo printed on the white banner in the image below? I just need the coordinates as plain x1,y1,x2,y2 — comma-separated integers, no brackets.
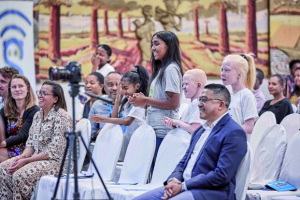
0,10,32,74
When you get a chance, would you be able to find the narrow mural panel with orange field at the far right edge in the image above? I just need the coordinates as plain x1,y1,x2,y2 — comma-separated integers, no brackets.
270,0,300,75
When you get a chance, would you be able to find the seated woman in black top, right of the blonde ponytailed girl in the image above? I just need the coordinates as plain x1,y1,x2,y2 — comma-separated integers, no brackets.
259,74,294,124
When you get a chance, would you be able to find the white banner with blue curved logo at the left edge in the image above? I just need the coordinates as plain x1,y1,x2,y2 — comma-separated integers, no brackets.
0,1,35,89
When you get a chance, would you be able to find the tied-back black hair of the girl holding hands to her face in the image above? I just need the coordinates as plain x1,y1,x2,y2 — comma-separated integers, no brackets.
119,65,149,113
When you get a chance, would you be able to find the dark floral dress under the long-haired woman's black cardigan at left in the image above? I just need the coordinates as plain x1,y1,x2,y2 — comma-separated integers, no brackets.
7,117,25,158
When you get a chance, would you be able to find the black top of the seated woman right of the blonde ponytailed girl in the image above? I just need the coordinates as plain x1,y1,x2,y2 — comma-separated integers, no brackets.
259,98,294,124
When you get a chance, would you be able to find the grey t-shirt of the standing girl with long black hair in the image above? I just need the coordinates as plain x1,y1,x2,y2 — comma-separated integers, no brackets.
146,63,182,138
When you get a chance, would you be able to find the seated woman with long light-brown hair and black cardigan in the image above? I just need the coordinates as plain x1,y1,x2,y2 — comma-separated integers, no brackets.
0,74,39,162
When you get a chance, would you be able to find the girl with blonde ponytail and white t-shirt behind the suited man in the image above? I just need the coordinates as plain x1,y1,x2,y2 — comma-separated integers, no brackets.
221,54,258,134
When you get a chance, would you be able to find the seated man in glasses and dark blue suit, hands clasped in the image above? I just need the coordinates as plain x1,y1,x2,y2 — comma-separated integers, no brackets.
135,84,247,200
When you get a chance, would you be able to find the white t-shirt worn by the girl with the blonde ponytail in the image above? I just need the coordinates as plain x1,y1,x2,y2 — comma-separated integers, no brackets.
228,88,258,125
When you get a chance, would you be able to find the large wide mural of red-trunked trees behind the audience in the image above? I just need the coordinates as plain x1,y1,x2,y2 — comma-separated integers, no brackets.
36,0,269,78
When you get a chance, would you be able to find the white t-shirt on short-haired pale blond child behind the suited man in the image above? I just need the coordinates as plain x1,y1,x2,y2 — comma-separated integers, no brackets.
180,99,205,125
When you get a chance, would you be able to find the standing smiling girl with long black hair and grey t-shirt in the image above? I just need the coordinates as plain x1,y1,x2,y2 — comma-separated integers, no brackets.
129,31,183,161
